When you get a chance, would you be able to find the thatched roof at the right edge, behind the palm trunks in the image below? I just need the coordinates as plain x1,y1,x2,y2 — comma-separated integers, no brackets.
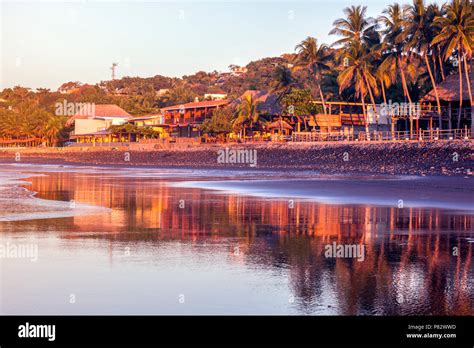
422,71,474,105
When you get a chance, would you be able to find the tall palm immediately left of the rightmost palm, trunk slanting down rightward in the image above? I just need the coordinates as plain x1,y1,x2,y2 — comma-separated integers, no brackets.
399,0,441,127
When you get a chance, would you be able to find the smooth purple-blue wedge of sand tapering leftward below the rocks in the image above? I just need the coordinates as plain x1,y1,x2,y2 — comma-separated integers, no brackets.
175,175,474,213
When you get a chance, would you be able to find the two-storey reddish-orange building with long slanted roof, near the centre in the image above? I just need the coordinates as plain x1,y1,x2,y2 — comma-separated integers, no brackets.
161,99,229,138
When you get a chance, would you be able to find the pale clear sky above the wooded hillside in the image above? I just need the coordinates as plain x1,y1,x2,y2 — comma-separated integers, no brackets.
0,0,444,90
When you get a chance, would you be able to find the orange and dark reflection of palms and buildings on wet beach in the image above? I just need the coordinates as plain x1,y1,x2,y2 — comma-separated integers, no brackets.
4,173,474,315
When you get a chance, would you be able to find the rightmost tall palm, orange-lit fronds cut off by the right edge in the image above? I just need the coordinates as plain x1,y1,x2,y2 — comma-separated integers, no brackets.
432,0,474,132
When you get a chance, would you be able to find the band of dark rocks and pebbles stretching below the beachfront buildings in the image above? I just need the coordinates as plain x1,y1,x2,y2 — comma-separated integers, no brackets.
0,141,474,177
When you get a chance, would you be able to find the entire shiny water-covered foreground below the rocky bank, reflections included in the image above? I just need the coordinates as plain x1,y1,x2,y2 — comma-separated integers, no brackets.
0,165,474,315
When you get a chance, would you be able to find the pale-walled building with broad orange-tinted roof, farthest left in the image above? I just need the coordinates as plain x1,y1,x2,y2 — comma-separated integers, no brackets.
66,104,131,143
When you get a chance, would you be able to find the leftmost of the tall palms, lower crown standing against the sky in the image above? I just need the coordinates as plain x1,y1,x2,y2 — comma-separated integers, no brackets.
295,37,331,114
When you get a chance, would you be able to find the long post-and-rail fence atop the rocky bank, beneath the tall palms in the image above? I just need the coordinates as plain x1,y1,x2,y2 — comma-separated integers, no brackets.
291,128,472,142
